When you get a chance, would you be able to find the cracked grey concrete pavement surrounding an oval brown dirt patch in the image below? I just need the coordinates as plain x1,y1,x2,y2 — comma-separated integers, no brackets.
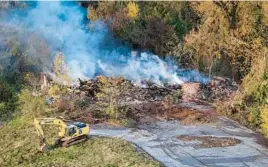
90,117,268,167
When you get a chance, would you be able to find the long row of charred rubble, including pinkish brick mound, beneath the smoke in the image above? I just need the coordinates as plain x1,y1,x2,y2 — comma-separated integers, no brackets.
70,76,238,102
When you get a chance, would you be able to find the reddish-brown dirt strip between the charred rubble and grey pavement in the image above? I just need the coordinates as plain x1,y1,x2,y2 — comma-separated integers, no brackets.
132,102,217,125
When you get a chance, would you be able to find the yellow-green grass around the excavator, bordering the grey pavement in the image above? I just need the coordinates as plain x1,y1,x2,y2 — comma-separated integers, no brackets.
0,92,161,167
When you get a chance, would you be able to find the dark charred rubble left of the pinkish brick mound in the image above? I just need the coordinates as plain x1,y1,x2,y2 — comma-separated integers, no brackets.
69,76,181,102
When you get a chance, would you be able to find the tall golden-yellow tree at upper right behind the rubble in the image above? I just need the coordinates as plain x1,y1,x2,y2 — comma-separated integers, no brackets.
185,1,264,80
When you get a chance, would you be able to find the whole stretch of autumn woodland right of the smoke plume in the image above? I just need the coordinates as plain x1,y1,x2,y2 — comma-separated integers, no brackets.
88,1,268,134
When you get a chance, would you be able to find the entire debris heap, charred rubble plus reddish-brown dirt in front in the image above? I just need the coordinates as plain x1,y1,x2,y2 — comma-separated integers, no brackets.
59,76,238,124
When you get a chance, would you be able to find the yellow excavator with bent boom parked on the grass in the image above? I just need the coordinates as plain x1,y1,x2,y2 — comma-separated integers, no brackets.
34,118,89,152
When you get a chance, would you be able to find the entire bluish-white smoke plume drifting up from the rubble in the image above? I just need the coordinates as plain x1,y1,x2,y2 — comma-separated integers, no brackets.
2,2,207,84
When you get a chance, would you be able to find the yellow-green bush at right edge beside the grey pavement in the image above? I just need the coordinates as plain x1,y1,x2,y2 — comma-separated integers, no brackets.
221,50,268,136
